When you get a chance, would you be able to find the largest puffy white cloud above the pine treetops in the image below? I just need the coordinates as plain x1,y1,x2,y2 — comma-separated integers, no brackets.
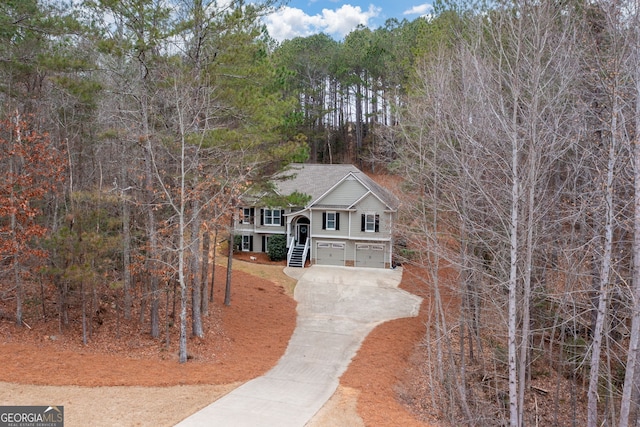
265,4,380,41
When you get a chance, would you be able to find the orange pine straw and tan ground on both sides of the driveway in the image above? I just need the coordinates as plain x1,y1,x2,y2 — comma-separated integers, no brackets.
0,254,436,427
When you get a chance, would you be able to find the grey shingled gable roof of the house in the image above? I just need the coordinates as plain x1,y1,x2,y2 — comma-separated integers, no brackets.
274,163,398,210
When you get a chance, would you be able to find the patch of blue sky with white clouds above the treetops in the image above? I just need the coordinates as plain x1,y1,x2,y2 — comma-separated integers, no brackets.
265,0,432,41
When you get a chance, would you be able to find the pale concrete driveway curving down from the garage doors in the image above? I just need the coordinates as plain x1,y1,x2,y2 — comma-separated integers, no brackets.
178,266,422,427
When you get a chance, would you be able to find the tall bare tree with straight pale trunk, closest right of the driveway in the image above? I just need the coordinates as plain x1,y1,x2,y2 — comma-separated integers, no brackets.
466,2,579,426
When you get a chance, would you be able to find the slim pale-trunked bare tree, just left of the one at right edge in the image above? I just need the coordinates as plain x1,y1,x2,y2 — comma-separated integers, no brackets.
587,2,629,427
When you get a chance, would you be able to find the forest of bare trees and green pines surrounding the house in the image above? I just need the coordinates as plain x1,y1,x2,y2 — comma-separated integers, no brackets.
0,0,640,427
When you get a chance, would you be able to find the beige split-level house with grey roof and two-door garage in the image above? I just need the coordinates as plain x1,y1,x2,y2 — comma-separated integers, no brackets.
235,164,398,268
